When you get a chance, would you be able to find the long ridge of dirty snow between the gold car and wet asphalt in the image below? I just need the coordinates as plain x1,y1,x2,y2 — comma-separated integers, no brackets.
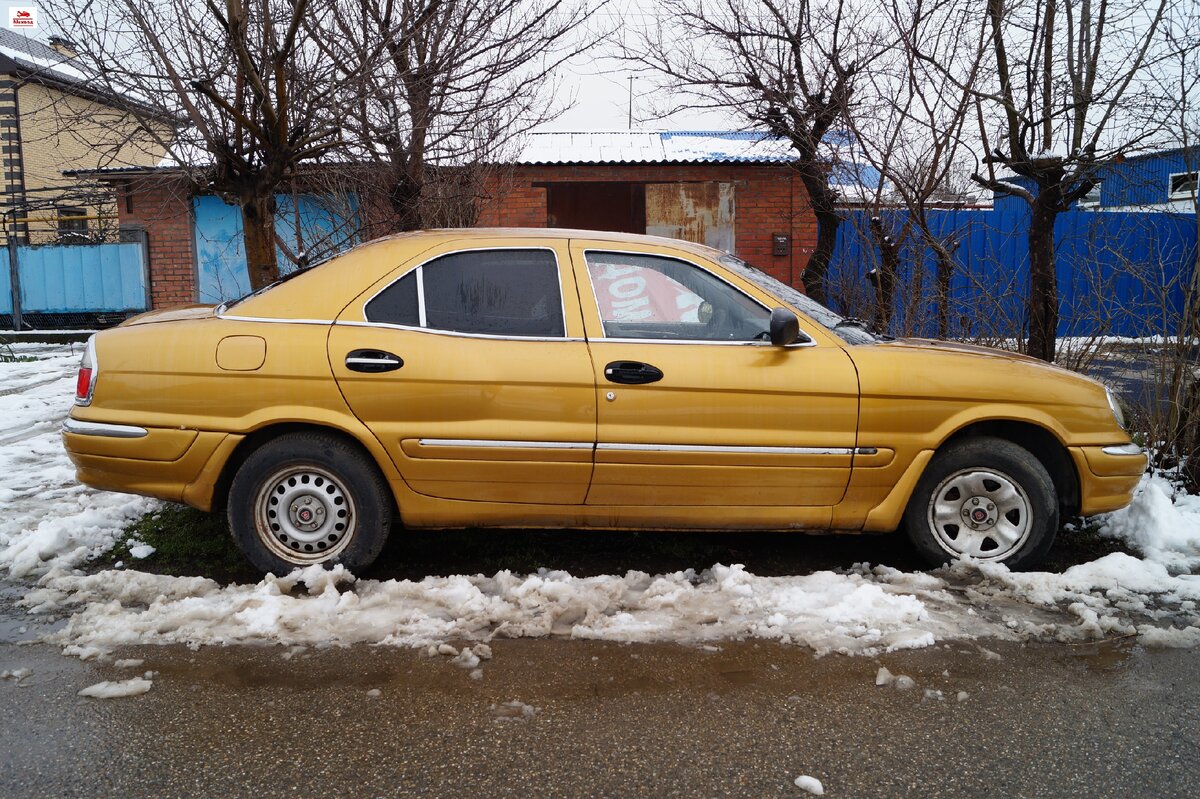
24,565,974,652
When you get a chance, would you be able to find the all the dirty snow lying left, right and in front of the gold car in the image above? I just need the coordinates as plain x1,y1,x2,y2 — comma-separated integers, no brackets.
0,346,1200,657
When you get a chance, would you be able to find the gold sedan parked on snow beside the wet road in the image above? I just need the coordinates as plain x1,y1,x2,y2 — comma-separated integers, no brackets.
62,229,1146,572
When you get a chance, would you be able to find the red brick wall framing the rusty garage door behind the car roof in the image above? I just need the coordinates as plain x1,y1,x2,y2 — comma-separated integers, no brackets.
479,163,817,286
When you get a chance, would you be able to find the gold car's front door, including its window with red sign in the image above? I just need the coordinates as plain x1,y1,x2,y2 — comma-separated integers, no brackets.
571,240,858,511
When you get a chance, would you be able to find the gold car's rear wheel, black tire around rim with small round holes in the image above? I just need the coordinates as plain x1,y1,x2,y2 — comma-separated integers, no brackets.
227,432,392,575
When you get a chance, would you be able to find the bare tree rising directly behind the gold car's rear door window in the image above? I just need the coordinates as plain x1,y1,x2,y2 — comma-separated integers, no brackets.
314,0,594,230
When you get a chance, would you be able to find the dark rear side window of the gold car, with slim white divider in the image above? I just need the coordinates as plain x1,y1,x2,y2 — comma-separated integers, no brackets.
366,250,565,338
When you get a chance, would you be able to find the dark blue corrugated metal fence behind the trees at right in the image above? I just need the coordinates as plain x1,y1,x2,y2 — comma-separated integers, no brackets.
829,210,1196,337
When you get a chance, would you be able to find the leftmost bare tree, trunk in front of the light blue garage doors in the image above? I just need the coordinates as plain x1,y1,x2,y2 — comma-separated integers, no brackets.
44,0,349,289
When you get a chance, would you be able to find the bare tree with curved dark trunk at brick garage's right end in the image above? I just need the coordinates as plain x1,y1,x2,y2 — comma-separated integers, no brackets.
623,0,882,301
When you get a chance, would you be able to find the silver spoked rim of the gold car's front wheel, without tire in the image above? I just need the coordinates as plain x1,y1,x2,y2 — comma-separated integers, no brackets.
928,468,1033,561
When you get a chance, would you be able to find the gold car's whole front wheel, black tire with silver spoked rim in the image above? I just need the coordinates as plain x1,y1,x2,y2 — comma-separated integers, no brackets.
904,437,1058,569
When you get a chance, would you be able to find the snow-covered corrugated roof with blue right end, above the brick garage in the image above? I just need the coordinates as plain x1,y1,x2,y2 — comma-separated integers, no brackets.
516,131,796,164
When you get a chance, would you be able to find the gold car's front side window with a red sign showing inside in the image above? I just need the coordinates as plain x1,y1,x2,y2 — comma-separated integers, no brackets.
587,252,770,341
